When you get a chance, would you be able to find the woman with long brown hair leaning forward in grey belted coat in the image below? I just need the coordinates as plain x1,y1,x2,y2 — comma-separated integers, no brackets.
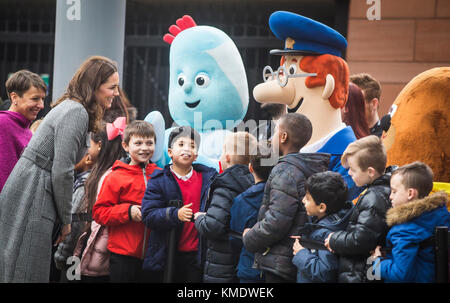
0,56,119,282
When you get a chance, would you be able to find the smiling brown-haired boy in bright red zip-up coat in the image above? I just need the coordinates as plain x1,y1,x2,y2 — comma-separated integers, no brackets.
93,121,158,282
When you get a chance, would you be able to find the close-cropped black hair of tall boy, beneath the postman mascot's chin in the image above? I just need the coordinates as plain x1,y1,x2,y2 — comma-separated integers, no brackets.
279,113,312,150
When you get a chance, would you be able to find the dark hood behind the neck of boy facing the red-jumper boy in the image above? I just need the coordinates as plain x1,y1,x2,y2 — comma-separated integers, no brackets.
213,164,255,192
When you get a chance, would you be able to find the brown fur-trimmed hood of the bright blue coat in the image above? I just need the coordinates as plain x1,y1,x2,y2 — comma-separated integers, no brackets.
386,191,448,226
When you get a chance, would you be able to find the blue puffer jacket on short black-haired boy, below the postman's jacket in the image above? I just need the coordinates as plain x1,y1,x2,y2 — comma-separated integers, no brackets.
292,201,354,283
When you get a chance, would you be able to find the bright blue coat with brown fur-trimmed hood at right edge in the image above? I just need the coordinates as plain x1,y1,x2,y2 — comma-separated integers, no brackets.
375,192,450,282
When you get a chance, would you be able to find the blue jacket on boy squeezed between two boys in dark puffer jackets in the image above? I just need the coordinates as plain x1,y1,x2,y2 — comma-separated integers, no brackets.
230,182,266,282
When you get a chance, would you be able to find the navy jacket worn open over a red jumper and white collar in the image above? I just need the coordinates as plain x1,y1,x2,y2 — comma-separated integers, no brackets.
142,164,217,271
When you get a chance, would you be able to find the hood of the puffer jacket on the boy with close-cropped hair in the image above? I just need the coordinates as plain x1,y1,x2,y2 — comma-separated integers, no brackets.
278,153,331,174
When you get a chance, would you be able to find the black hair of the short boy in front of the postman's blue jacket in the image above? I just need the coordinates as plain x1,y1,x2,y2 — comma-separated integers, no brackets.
305,171,348,215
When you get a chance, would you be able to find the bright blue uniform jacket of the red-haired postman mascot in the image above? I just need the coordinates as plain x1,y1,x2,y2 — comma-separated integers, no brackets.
317,126,362,200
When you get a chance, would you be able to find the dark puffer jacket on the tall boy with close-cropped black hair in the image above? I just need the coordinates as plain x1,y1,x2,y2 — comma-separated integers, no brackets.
243,153,330,282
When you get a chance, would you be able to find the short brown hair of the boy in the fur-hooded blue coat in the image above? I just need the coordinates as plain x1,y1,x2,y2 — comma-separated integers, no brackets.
391,161,433,199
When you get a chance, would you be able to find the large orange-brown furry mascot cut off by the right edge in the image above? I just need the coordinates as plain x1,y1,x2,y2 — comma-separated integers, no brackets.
383,67,450,182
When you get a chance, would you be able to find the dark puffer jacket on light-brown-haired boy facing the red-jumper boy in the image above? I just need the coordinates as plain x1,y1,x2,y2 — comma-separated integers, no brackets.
195,164,255,283
